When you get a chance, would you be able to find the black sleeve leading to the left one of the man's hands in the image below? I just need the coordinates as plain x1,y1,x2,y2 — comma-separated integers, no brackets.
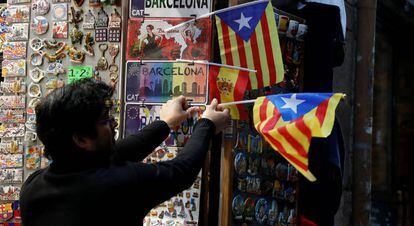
112,121,171,163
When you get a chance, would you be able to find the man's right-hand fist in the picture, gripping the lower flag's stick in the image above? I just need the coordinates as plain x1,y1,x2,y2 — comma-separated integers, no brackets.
202,98,230,134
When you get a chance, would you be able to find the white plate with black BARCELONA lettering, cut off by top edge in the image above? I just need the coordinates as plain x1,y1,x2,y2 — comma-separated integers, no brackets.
130,0,212,17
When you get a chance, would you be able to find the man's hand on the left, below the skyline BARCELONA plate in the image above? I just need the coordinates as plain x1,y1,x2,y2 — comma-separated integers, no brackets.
160,96,198,129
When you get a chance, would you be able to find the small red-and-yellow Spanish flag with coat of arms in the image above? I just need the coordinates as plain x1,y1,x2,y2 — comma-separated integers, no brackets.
208,65,249,119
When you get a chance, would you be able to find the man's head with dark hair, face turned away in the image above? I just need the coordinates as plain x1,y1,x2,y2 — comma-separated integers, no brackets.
36,79,117,160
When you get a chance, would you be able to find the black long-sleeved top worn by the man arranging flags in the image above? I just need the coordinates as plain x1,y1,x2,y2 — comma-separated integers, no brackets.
20,119,215,226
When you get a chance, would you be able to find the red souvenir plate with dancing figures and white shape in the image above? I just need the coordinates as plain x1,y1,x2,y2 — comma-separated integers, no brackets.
126,18,211,60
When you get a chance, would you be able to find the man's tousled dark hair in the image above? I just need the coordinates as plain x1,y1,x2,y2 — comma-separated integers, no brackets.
36,79,113,159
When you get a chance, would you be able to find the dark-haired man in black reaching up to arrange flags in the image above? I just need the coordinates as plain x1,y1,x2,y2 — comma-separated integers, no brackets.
20,79,229,226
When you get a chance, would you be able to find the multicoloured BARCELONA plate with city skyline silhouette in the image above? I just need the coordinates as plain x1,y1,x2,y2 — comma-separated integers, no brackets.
125,61,208,104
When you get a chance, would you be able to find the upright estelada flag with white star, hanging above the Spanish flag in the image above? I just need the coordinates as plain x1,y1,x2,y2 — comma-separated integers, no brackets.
216,1,284,89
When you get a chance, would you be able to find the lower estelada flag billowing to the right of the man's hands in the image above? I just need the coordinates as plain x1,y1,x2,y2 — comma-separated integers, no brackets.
253,93,345,181
